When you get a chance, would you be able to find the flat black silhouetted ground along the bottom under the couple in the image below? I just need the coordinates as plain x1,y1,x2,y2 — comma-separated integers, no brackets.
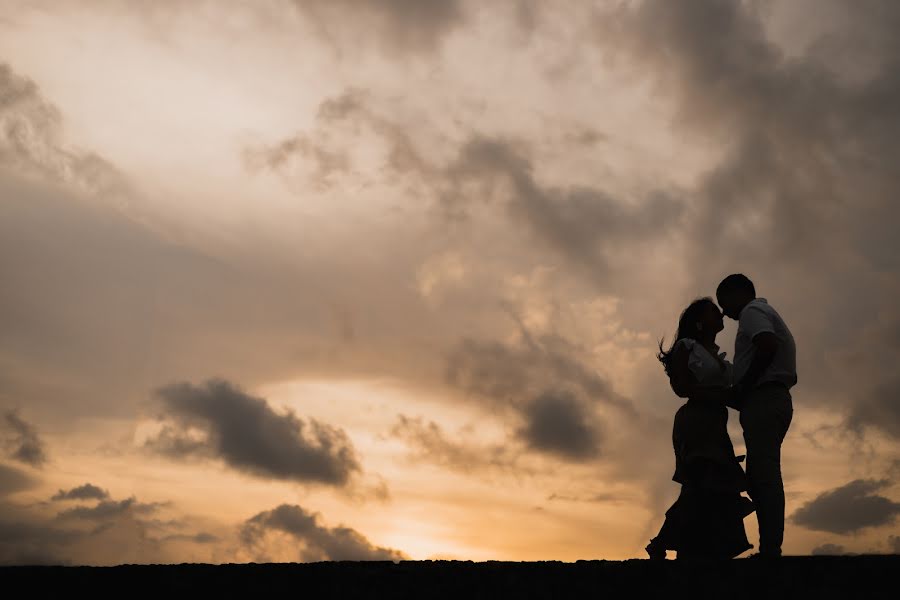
0,555,900,600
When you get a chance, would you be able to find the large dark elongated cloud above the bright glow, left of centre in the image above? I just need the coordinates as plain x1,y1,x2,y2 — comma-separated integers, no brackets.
147,379,361,485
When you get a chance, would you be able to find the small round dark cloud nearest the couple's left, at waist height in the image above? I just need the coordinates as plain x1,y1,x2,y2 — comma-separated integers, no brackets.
519,391,600,460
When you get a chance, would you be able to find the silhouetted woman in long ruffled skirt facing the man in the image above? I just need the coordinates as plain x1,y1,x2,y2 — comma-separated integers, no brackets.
646,298,753,559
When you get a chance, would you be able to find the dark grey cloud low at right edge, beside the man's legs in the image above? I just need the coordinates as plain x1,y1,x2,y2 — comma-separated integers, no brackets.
791,479,900,534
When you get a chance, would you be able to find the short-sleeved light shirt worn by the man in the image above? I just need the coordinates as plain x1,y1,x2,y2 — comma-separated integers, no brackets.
734,298,797,388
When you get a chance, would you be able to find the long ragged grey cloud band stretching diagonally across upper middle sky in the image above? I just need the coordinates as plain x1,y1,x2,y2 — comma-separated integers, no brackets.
255,88,685,290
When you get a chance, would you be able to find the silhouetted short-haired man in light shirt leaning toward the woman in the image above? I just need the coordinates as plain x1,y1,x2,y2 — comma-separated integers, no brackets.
716,274,797,557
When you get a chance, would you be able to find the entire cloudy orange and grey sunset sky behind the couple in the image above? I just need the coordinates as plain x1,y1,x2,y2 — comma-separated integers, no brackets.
0,0,900,565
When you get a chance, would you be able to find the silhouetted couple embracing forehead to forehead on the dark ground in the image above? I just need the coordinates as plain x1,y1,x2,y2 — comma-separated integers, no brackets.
646,274,797,559
